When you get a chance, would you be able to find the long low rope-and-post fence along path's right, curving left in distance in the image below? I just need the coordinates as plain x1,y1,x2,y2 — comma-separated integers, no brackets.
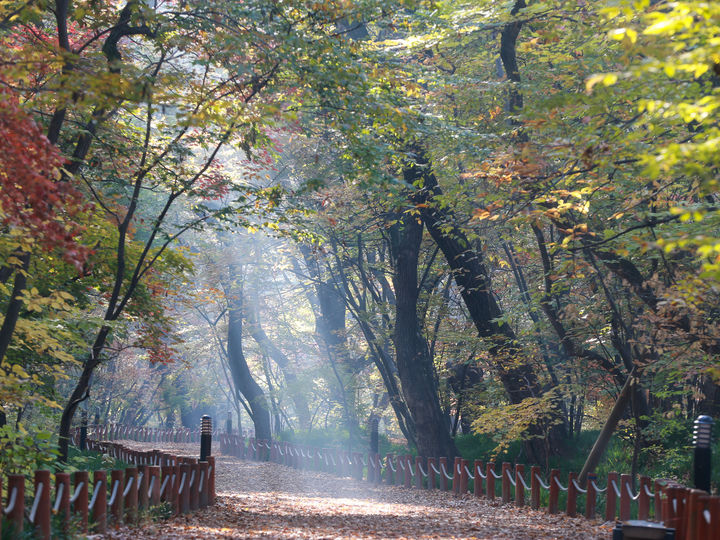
54,426,720,540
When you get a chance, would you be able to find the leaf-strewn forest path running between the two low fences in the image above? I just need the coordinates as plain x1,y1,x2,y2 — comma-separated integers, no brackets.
108,441,611,540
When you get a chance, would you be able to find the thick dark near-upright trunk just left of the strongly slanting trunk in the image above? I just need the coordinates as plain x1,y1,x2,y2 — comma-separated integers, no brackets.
390,209,457,458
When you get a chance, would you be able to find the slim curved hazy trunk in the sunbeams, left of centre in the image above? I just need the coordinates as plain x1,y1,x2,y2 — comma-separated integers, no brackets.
227,265,272,440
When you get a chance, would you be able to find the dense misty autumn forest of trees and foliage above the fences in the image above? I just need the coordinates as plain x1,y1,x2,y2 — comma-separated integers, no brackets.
0,0,720,490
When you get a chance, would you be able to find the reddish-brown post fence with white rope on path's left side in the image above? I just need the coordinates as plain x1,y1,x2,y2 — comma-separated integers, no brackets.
0,430,215,539
